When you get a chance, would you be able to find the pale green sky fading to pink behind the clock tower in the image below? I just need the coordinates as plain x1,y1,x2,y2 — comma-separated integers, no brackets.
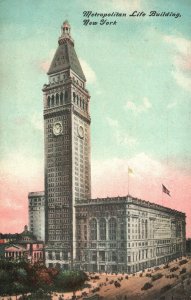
0,0,191,237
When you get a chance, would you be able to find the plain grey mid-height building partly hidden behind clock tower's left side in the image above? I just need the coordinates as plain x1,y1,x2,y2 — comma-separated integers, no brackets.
28,192,45,241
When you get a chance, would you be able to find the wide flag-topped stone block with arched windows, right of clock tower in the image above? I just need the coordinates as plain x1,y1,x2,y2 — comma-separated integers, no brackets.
76,196,185,273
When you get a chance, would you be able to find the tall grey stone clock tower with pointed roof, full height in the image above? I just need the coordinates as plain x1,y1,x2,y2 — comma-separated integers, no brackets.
43,21,91,268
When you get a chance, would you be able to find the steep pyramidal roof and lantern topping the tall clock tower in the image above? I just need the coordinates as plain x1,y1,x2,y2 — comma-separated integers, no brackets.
47,21,86,81
